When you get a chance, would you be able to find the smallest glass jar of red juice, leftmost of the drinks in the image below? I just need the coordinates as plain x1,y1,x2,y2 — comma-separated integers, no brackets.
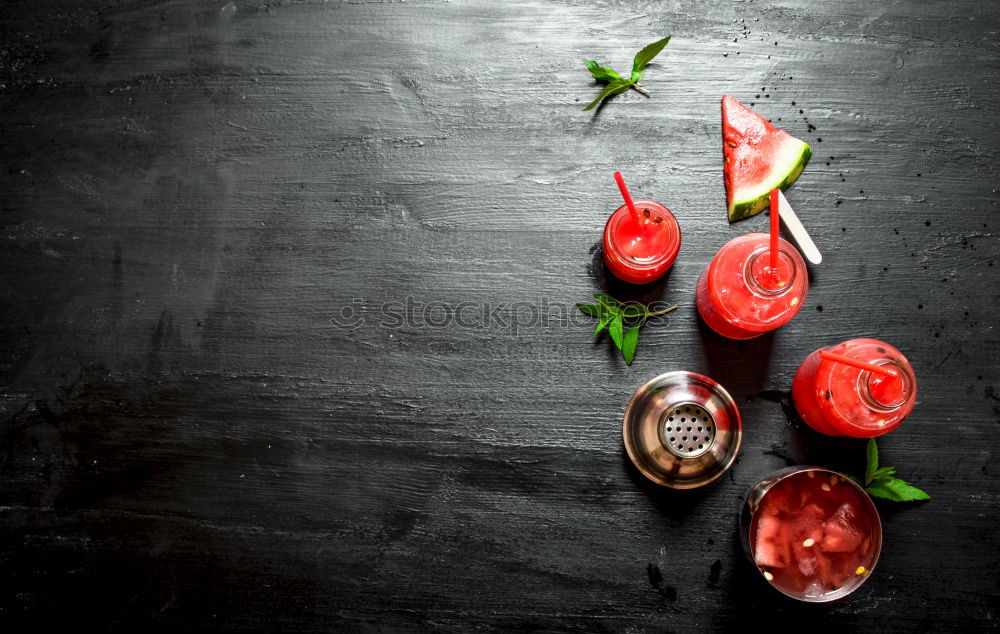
603,200,681,284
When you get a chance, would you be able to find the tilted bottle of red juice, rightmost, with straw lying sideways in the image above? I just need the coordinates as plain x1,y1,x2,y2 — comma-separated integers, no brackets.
792,339,917,438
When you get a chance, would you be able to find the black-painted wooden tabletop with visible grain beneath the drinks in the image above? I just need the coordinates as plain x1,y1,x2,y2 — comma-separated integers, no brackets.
0,0,1000,632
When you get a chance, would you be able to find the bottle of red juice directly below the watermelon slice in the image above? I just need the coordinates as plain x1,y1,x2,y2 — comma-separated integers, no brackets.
696,233,809,339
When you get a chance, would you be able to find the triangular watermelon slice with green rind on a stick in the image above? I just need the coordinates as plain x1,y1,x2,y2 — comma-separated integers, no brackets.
722,95,812,222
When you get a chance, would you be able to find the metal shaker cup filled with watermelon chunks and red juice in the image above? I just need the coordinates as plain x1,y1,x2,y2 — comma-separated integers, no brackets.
740,466,882,603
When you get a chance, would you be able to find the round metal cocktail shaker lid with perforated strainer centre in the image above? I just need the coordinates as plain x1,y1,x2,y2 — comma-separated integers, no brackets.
622,371,743,489
